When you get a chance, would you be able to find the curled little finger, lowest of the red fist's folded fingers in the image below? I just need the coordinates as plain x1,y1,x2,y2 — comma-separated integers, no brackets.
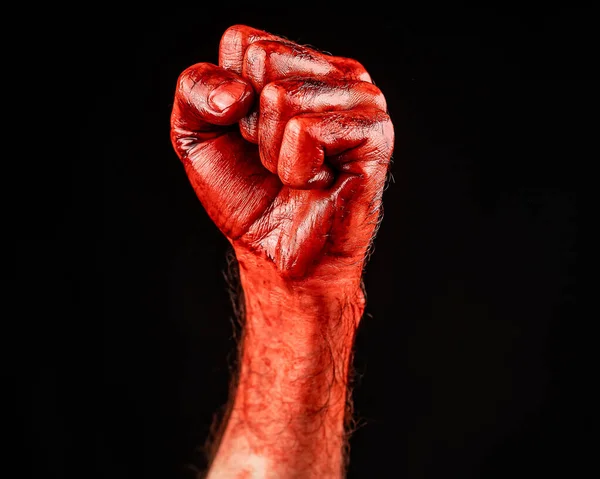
278,108,394,191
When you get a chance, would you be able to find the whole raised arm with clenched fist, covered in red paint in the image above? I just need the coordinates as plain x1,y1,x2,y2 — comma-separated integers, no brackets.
171,25,394,479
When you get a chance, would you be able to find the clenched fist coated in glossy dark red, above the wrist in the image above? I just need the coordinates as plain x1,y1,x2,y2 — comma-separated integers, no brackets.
171,25,394,281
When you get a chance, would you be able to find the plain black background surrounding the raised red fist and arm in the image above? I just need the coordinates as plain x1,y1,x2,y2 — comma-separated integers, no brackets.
16,2,591,479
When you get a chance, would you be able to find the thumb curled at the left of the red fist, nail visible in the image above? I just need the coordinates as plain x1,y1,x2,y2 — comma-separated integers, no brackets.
171,63,281,239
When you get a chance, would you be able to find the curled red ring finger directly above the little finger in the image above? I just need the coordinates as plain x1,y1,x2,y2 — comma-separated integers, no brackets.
258,78,387,175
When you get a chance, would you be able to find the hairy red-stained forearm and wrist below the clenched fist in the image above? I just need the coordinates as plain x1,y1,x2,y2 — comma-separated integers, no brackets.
208,251,364,479
